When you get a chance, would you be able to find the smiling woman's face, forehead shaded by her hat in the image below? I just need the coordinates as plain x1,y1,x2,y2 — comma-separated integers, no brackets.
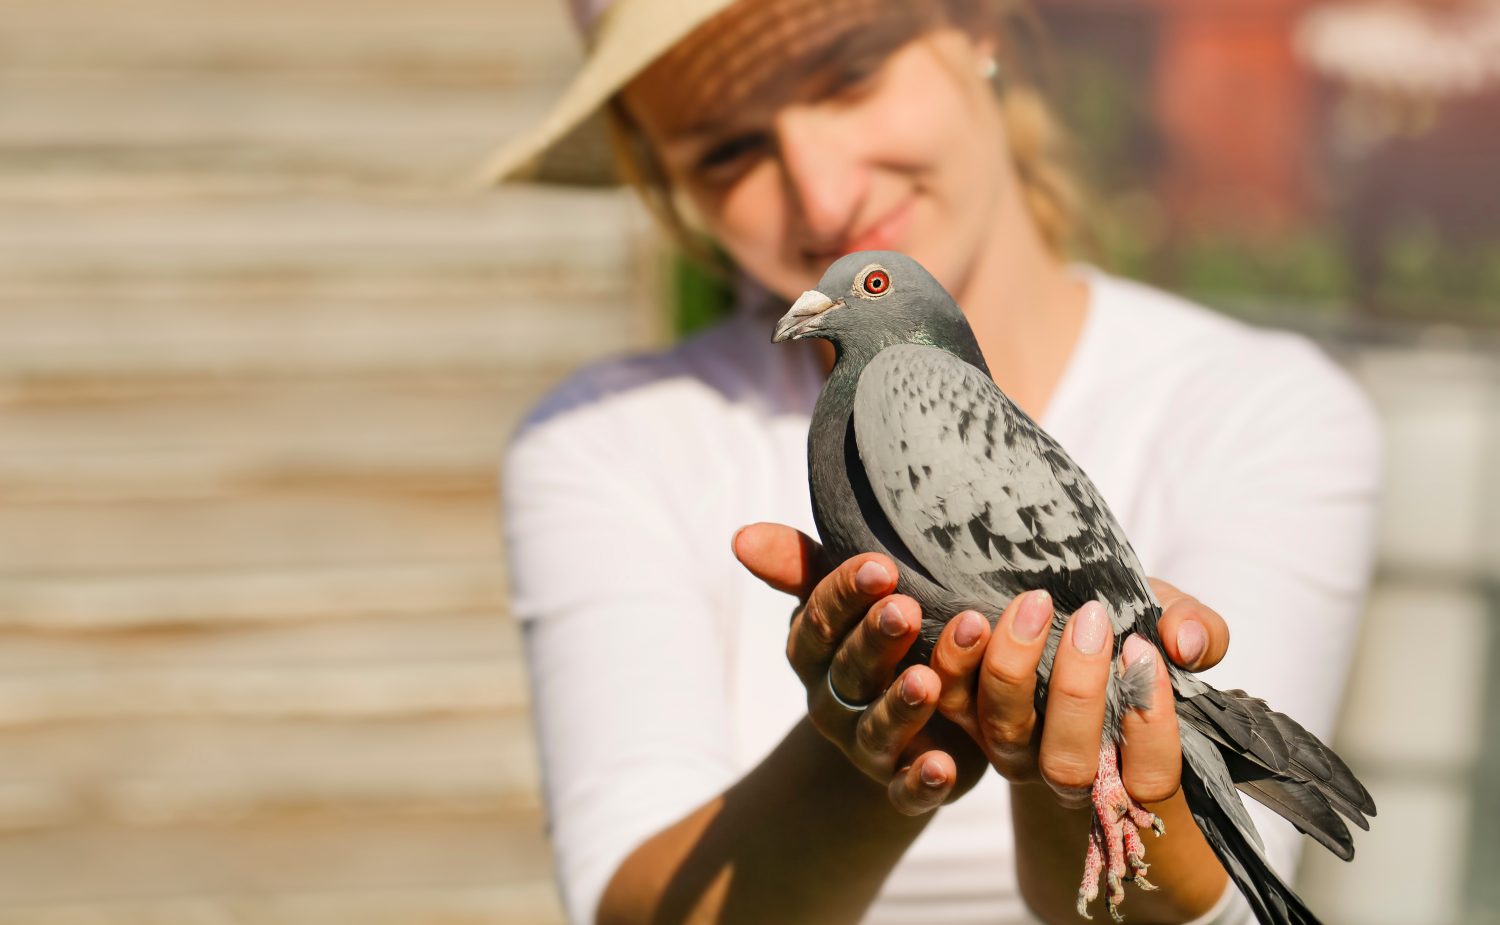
624,0,1023,298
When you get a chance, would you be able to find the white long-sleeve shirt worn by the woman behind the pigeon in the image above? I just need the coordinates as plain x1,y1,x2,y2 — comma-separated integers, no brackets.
503,268,1379,925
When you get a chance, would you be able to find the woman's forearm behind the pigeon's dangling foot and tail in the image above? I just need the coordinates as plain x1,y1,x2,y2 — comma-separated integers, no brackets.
1011,784,1227,925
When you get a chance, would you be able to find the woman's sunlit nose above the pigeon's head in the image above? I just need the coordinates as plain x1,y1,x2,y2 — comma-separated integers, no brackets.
776,106,869,246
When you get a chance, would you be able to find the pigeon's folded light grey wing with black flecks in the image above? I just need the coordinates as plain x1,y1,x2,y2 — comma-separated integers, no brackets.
854,343,1158,633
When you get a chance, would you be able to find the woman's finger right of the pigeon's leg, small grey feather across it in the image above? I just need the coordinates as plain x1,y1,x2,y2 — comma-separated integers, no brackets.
1119,633,1182,804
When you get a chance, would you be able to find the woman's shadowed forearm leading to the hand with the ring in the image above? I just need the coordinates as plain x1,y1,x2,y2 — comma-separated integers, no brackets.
597,718,932,925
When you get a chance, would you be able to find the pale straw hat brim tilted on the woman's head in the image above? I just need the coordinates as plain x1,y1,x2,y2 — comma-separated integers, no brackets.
480,0,734,186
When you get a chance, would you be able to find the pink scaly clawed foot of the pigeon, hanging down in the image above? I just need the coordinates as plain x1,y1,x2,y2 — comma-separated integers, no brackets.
1079,742,1166,922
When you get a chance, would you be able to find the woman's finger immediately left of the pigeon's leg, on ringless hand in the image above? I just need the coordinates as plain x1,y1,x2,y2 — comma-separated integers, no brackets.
1037,601,1115,805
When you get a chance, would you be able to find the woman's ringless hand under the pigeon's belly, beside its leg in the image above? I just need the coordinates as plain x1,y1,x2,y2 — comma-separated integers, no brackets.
932,579,1229,807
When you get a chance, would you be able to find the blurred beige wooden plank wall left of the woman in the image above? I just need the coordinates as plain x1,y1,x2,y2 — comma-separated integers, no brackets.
0,0,659,925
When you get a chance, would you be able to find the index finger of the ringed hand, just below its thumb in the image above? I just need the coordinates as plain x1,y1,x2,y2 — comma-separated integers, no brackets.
786,553,896,693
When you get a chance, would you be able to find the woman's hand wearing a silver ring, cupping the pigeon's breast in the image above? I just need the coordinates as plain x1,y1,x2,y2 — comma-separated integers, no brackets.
734,523,989,816
